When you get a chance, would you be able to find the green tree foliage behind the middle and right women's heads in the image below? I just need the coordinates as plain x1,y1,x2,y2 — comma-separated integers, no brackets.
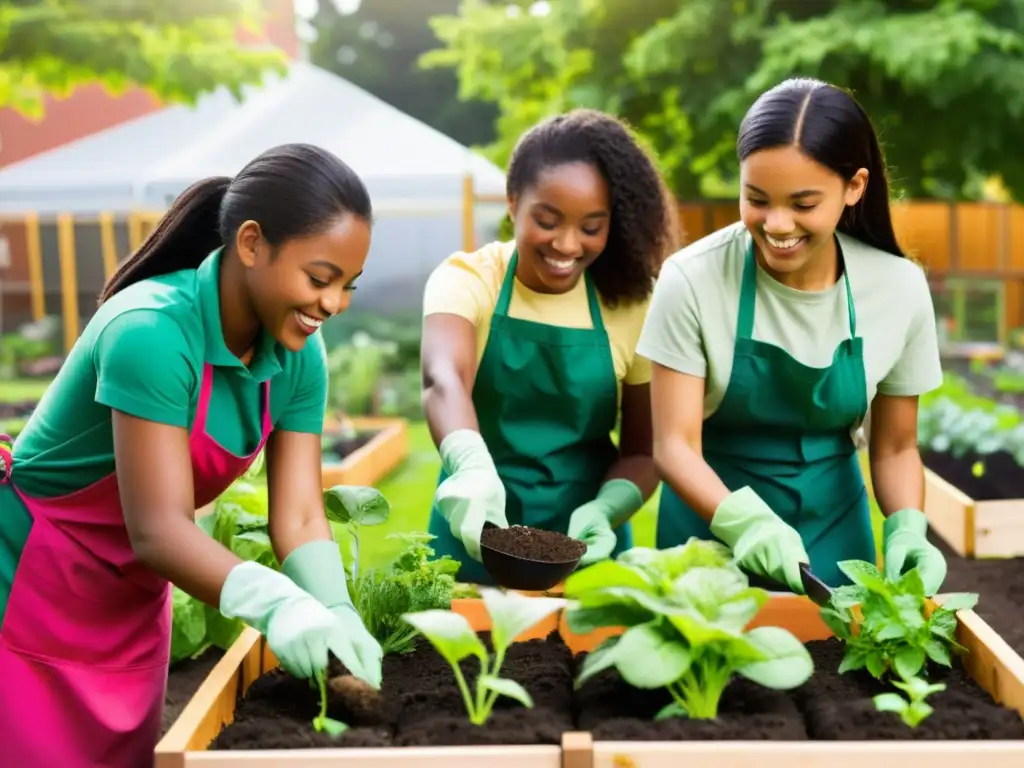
421,0,1024,199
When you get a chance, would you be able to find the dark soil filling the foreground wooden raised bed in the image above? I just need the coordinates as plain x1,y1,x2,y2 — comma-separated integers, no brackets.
210,634,1024,750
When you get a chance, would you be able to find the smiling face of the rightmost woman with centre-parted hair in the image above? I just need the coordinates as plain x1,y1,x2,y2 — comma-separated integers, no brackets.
739,146,867,276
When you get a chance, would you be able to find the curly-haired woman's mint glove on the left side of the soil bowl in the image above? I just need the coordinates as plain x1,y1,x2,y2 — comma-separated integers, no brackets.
434,429,509,562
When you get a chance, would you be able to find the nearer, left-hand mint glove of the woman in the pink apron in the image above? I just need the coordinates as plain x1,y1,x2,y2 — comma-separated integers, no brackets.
219,561,382,684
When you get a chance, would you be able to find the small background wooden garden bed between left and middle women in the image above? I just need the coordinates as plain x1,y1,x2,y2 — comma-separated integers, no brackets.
323,417,409,488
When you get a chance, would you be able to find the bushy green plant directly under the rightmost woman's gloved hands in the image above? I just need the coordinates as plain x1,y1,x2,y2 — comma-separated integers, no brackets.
821,560,978,681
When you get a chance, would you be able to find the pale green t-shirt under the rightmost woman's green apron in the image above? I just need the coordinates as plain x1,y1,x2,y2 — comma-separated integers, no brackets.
637,222,942,431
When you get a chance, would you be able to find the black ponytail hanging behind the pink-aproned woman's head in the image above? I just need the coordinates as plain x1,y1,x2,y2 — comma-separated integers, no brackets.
99,176,231,304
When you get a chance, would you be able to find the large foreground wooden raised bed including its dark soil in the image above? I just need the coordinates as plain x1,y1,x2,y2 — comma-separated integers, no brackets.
156,595,1024,768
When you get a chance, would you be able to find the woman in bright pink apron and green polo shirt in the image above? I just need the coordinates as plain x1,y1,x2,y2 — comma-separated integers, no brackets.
0,144,381,768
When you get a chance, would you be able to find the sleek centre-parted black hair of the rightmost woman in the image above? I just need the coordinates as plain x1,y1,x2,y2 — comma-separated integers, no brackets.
736,78,905,256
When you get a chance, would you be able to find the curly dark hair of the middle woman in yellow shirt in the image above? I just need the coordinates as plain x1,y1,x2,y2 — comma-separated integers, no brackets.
506,110,681,306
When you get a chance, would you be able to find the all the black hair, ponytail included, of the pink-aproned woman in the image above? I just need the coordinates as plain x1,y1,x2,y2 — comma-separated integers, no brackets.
99,143,373,304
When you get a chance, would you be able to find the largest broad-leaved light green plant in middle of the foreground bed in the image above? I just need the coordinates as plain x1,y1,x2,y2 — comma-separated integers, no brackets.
565,539,813,719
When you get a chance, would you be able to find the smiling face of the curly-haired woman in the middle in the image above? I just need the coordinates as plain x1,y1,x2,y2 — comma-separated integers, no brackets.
509,163,611,293
